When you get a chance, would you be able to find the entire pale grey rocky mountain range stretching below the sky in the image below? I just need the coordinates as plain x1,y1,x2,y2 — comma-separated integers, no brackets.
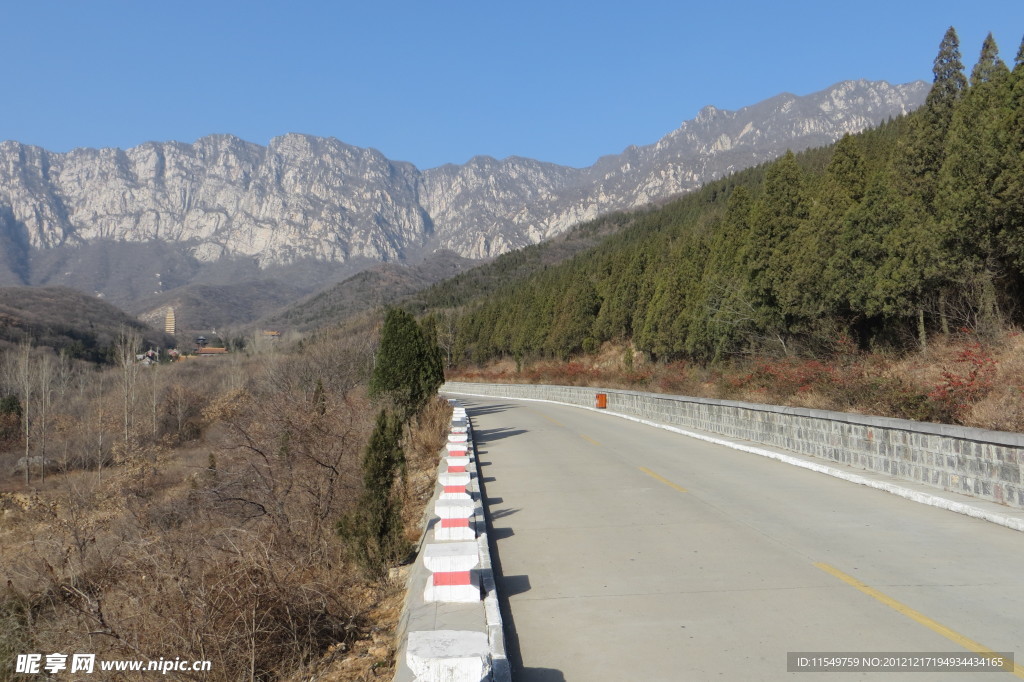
0,81,928,311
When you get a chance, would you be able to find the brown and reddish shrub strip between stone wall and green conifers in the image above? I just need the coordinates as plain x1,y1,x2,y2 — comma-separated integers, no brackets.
449,331,1024,431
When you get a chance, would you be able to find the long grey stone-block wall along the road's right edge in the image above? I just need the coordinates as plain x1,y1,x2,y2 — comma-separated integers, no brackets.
441,382,1024,509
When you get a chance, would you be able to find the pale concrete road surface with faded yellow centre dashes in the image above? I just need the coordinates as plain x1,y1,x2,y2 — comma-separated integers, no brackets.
462,397,1024,682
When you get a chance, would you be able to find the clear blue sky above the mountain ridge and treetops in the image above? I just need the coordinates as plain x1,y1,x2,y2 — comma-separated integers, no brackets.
0,0,1024,169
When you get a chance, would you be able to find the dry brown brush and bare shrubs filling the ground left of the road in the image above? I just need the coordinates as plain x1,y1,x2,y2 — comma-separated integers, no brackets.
0,323,446,682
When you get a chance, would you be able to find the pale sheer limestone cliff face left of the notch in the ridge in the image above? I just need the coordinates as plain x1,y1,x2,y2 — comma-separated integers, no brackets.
0,134,430,264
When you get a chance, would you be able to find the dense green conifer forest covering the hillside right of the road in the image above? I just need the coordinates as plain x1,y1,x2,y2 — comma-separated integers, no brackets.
452,29,1024,363
